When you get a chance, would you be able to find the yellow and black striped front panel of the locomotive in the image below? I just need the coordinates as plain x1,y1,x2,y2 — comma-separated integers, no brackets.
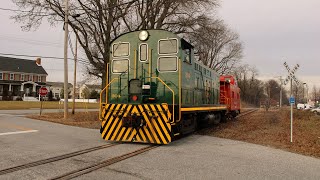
101,104,172,144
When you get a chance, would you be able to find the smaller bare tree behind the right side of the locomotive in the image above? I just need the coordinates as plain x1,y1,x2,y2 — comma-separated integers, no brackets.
192,18,243,74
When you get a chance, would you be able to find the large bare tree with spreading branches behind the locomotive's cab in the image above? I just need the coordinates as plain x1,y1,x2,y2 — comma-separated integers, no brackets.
13,0,218,87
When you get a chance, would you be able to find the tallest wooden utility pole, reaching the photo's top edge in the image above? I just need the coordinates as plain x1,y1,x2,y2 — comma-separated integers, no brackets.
64,0,69,119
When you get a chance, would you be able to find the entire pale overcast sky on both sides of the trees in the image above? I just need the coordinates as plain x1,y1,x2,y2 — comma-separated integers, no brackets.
0,0,320,87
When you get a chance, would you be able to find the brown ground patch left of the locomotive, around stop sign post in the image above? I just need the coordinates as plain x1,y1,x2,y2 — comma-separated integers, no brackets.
28,111,101,129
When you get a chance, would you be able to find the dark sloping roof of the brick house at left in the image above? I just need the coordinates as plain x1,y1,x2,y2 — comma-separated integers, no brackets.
0,56,48,75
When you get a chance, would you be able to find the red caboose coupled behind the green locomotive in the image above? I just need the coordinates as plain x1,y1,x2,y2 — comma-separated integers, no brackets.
220,75,240,117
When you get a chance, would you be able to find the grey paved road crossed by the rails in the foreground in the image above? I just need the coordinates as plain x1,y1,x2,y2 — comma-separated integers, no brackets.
0,112,320,179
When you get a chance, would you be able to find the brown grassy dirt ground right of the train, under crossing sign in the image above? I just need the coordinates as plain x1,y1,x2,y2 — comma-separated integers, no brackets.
198,109,320,158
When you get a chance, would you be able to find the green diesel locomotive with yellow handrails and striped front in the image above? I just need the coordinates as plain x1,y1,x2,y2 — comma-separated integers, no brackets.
100,30,227,144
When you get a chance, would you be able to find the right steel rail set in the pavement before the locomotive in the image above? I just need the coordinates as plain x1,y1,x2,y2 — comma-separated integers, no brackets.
51,145,159,180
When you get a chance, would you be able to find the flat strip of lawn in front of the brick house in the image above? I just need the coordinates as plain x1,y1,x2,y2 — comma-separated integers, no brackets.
0,101,99,110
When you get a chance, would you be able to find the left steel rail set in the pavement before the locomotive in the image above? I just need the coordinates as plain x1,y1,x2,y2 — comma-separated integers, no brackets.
0,144,118,175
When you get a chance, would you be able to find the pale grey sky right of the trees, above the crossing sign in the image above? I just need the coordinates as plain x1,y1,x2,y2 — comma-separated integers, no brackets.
218,0,320,87
